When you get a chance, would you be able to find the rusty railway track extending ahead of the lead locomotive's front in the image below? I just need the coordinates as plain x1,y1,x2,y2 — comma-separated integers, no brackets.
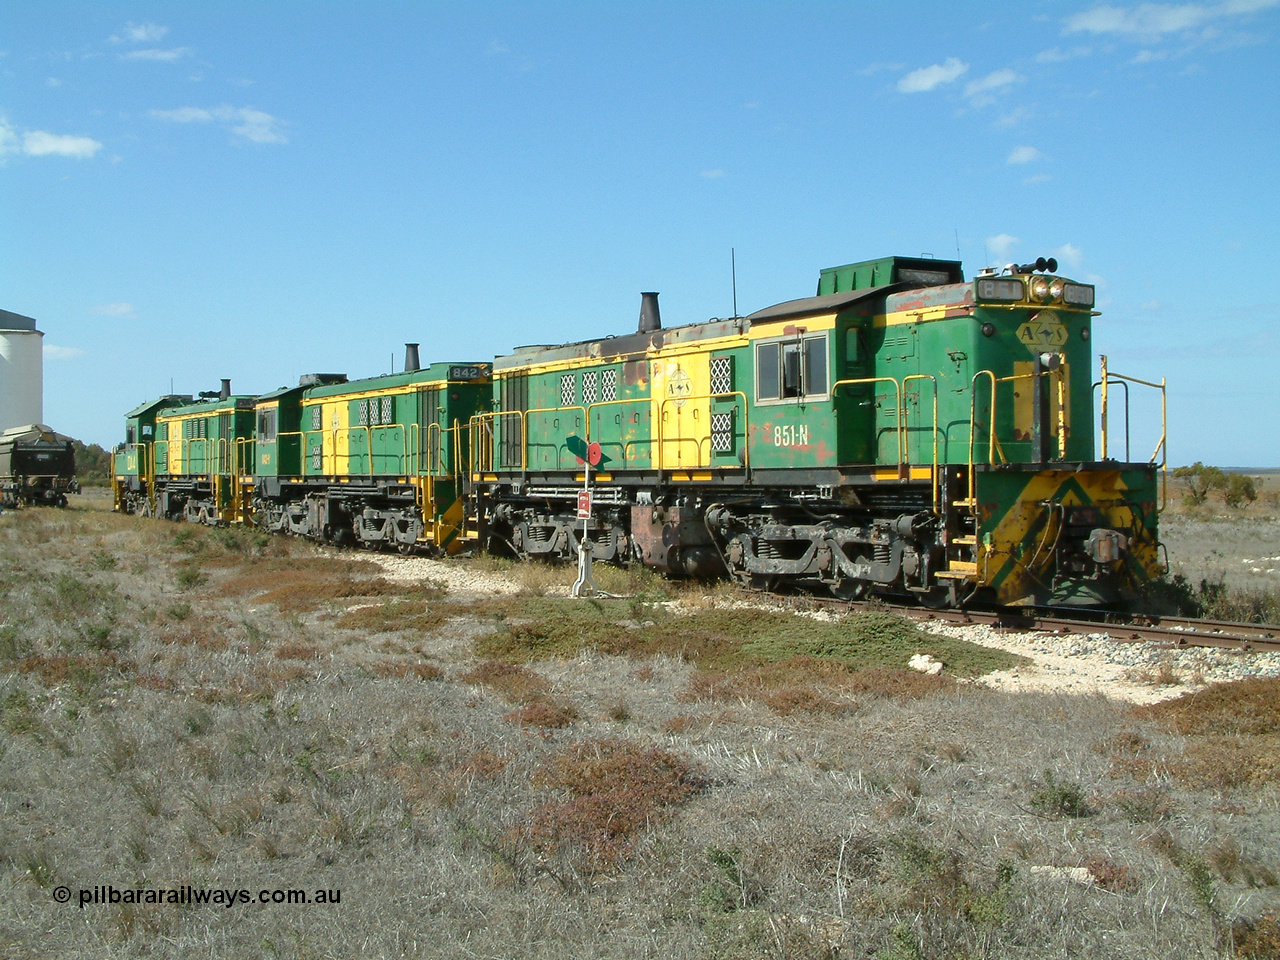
832,600,1280,653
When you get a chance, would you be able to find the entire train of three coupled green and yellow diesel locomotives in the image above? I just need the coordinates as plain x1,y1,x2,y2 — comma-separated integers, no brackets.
115,257,1166,605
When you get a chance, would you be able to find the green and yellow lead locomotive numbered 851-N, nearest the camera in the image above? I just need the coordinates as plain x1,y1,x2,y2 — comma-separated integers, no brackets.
474,257,1164,604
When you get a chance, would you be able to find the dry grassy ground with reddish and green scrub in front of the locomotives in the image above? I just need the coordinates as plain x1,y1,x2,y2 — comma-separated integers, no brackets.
0,499,1280,960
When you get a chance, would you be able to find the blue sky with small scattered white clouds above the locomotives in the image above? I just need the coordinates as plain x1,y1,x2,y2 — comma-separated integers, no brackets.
0,0,1280,466
